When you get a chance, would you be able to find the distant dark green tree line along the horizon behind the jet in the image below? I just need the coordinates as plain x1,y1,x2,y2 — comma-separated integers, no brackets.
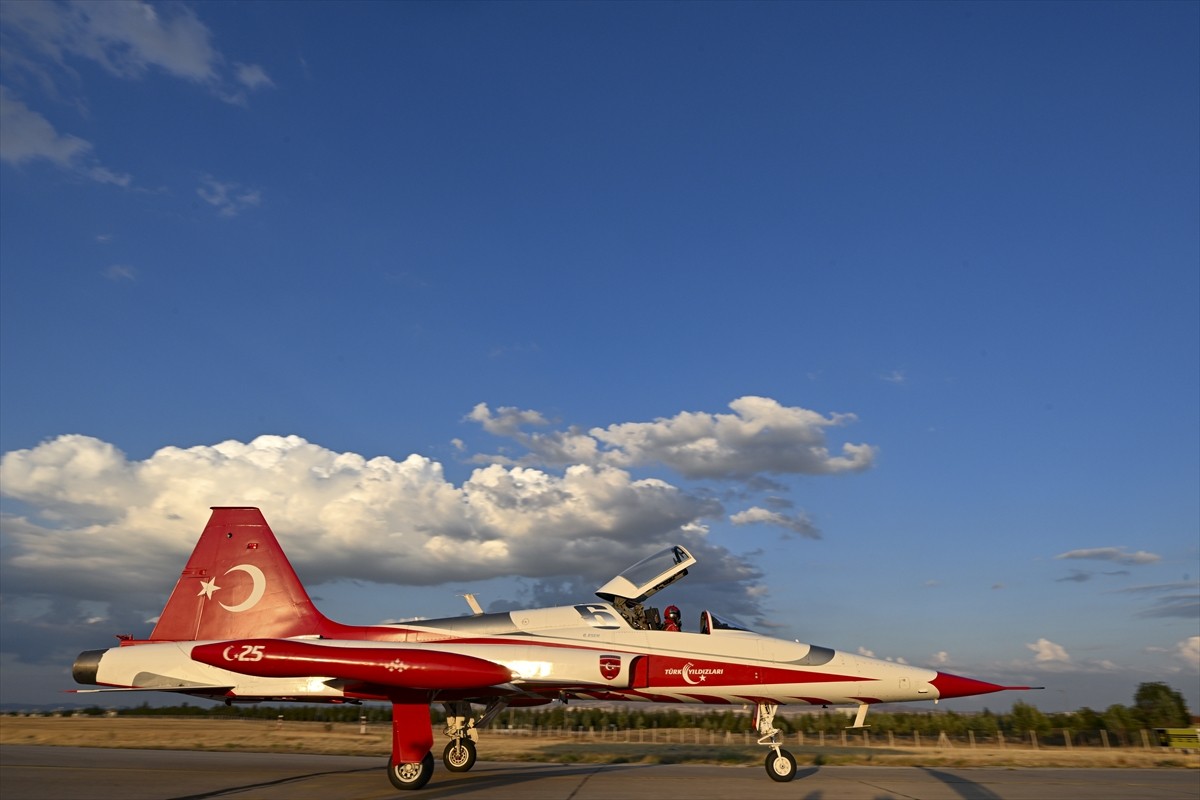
49,682,1192,736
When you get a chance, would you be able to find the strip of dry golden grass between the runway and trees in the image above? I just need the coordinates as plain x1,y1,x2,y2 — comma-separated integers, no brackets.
0,716,1200,769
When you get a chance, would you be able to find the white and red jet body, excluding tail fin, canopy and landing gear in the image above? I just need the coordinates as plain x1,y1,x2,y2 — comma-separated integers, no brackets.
76,602,984,705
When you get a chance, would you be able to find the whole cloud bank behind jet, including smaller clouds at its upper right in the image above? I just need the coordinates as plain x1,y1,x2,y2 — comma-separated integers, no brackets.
0,398,871,647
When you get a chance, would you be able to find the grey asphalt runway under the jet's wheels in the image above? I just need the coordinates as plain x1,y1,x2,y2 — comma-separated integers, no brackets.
0,745,1200,800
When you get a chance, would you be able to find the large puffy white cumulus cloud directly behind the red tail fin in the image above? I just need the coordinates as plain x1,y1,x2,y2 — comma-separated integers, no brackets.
0,435,734,596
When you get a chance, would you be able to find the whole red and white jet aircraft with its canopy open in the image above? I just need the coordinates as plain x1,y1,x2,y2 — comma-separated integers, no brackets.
73,507,1032,789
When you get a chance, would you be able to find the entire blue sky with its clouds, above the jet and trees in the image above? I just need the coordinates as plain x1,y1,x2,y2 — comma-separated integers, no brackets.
0,0,1200,710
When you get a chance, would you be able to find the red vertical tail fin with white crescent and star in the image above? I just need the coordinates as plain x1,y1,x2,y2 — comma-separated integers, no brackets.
150,507,330,640
